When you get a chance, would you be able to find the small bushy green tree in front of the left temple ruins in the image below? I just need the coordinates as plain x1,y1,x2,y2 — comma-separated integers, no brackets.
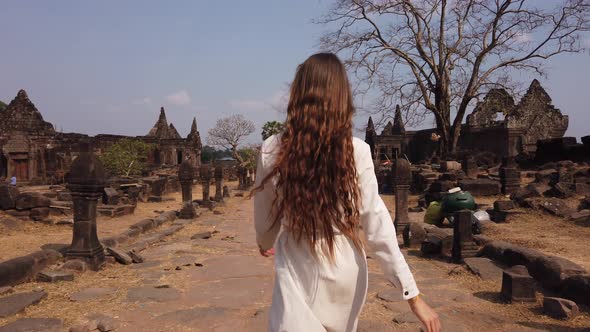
100,138,154,176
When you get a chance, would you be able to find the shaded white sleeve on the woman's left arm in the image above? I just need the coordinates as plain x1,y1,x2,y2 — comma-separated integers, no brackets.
254,144,281,250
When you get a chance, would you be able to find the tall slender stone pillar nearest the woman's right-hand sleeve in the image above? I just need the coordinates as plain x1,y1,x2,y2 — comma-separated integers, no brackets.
392,158,412,234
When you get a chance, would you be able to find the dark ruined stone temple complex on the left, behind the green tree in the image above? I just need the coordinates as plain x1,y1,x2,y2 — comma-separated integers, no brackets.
0,90,202,184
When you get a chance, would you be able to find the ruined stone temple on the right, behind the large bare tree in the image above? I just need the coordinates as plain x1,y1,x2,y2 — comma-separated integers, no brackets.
365,80,568,164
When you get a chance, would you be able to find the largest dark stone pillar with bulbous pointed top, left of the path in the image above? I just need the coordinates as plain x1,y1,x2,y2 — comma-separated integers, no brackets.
66,146,105,271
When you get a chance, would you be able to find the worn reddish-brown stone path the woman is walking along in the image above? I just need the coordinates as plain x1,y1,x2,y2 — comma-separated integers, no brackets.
0,193,588,332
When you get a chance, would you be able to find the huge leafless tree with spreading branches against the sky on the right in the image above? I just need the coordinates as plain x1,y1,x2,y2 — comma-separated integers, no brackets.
318,0,590,154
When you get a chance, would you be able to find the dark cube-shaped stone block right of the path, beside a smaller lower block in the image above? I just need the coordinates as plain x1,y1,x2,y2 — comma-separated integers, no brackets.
501,265,536,302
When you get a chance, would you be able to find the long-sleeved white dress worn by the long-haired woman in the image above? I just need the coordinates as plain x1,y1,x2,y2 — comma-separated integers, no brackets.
254,136,419,332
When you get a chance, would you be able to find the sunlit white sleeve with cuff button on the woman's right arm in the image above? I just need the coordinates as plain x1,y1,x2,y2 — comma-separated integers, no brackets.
359,144,420,300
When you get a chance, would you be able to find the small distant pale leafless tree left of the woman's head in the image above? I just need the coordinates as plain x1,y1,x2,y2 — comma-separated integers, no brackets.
207,114,255,165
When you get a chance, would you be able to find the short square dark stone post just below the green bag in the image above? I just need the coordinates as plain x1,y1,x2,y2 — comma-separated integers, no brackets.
452,210,478,262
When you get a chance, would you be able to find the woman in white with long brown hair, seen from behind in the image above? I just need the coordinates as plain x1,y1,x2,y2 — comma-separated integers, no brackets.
253,53,441,332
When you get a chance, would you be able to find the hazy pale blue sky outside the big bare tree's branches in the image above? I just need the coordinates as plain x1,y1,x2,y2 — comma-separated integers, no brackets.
0,0,590,142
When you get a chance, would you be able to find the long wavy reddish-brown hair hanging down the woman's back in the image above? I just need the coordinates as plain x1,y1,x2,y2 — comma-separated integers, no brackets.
253,53,363,258
